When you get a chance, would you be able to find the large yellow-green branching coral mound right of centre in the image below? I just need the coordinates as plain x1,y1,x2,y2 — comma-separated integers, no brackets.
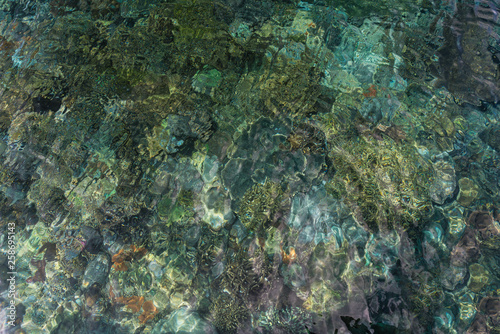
326,120,438,231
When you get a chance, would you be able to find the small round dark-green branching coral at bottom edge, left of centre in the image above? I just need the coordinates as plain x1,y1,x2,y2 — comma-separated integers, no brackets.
211,293,248,334
